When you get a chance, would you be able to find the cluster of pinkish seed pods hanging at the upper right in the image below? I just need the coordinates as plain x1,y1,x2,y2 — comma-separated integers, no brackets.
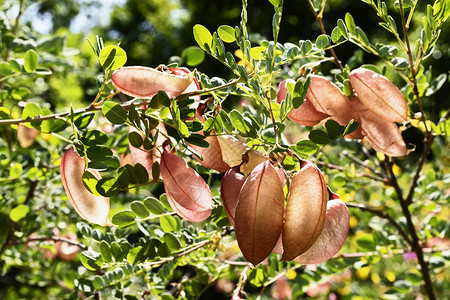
277,68,408,156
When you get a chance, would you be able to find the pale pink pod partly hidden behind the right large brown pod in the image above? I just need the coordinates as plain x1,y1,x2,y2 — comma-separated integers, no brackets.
294,193,350,264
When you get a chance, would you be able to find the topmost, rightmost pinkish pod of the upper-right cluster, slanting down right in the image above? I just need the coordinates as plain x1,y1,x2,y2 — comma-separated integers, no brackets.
350,68,408,122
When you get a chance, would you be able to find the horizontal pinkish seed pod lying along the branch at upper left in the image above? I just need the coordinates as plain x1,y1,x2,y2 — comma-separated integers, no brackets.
111,66,194,99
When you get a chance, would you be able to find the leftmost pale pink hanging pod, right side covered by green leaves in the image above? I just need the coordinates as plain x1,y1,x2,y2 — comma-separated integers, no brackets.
60,147,111,226
